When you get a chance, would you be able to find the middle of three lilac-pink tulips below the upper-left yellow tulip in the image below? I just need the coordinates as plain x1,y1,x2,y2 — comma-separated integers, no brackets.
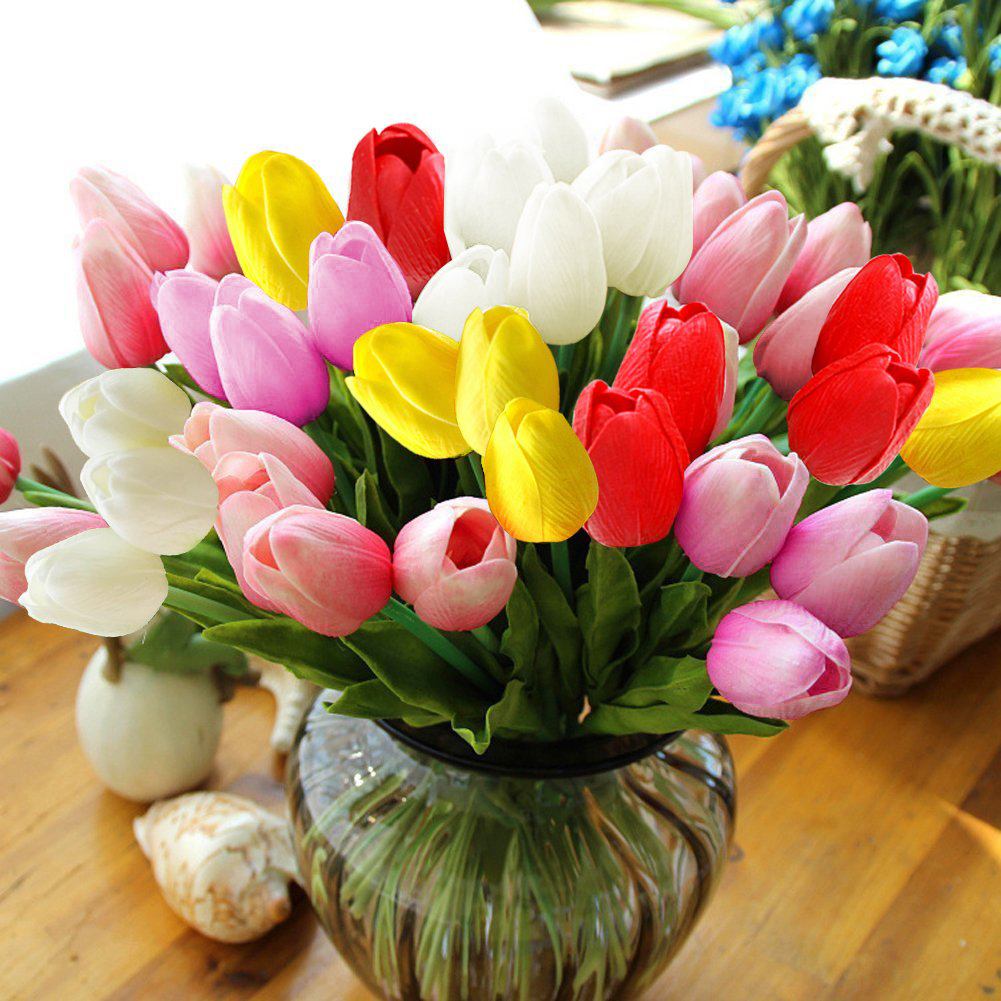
209,274,330,425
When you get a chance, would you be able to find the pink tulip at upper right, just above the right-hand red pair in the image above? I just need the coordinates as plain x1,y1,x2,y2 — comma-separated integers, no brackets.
776,201,873,313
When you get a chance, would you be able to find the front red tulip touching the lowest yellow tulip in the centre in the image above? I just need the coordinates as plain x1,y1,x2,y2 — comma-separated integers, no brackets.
574,379,689,546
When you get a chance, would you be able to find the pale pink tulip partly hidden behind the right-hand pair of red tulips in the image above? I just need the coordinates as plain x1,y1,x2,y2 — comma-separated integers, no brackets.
754,267,859,399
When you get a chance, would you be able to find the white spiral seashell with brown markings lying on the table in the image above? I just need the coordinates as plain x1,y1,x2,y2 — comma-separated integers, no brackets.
133,792,298,942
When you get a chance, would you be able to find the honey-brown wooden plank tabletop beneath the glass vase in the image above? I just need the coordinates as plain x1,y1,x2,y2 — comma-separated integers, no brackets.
0,615,1001,1001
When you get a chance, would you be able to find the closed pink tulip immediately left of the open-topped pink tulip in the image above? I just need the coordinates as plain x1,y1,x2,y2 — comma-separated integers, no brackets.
243,506,392,636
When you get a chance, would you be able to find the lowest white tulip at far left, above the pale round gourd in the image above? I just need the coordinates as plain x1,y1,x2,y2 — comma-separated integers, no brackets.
21,529,167,636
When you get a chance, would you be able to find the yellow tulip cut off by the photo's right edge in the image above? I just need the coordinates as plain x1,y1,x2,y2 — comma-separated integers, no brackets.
901,368,1001,486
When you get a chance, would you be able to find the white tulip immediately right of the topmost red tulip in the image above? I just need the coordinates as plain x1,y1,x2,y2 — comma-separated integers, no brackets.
444,135,553,257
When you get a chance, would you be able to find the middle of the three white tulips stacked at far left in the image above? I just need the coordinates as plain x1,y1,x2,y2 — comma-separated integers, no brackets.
80,445,218,556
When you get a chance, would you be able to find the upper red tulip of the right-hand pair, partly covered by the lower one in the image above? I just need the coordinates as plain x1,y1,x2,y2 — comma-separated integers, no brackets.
813,253,938,372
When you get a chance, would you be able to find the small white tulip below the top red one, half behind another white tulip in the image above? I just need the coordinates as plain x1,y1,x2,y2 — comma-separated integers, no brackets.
413,244,511,340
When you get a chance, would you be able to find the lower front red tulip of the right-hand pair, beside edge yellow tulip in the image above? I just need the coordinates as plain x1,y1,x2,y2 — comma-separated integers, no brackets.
789,344,935,485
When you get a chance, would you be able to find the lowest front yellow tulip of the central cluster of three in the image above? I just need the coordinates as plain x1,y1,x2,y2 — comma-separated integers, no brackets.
483,397,598,543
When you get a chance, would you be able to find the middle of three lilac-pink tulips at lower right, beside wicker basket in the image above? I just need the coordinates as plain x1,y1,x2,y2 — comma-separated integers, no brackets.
772,490,928,636
